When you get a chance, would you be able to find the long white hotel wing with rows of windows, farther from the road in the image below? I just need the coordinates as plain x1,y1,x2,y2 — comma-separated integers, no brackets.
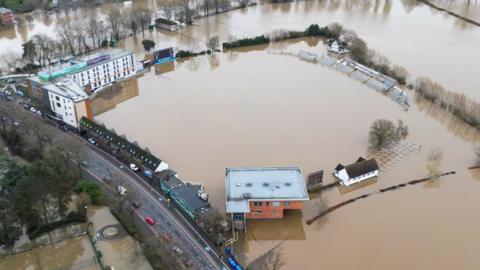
67,49,136,91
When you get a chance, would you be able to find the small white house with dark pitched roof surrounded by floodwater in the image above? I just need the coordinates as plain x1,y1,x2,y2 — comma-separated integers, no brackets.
333,157,379,186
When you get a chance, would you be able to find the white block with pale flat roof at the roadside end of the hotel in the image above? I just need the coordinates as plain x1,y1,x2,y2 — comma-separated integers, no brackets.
43,79,91,128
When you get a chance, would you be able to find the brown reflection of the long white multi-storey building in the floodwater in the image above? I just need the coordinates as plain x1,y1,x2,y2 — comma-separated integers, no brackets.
92,78,138,116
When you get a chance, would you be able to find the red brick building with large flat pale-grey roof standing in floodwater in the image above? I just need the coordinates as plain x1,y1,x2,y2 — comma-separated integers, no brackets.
225,167,308,232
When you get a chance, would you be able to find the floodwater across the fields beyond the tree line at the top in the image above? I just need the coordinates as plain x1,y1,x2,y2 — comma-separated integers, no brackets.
0,0,480,99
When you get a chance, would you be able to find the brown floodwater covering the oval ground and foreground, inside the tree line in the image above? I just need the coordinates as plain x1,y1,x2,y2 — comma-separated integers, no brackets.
97,39,480,269
